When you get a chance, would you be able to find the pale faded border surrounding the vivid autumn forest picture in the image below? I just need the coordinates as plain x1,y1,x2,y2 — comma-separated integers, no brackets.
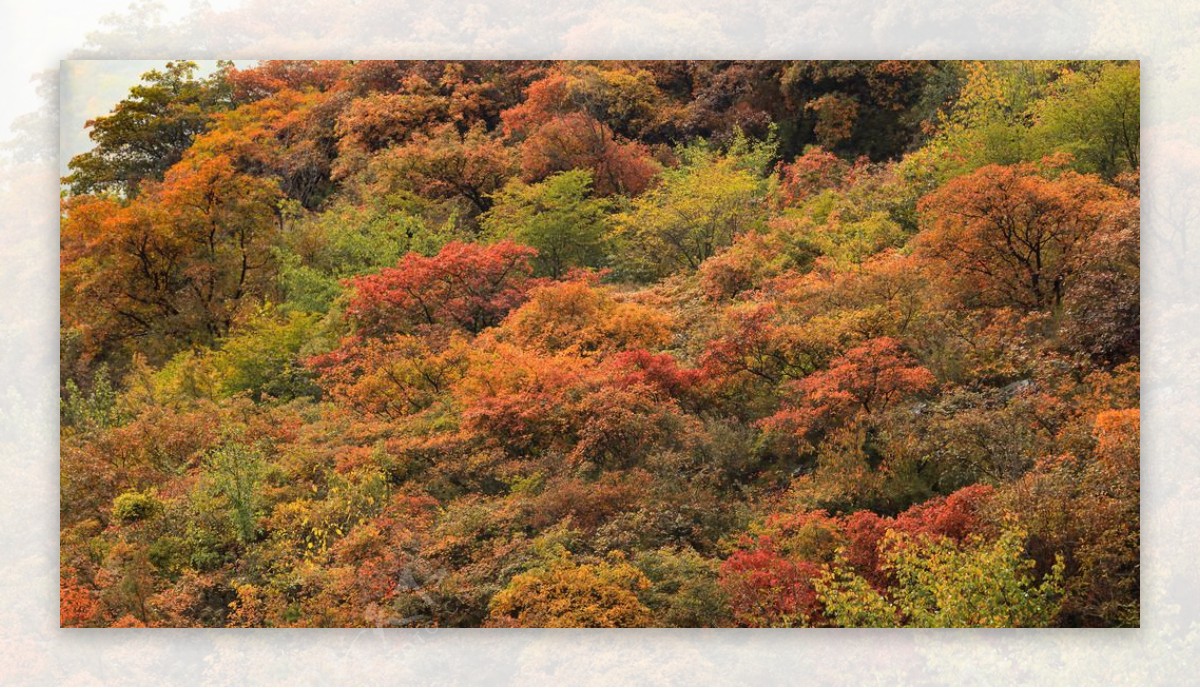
0,0,1200,684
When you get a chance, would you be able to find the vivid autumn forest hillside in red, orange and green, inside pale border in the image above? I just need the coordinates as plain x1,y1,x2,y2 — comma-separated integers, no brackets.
60,60,1140,628
